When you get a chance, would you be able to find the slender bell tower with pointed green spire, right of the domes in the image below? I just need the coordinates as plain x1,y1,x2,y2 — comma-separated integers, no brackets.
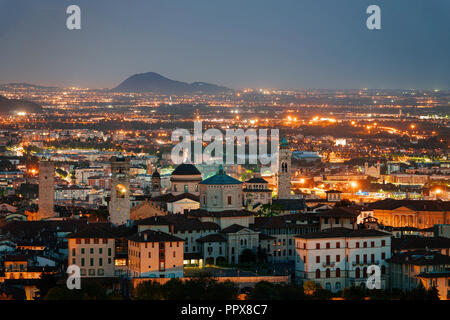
277,137,292,199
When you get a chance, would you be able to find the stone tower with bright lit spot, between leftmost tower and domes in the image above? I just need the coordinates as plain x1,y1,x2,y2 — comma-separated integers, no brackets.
109,157,130,225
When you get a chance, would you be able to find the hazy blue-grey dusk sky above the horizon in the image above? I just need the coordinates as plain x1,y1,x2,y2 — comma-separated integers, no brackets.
0,0,450,89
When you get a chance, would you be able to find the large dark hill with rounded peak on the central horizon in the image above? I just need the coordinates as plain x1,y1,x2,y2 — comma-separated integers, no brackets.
112,72,231,95
